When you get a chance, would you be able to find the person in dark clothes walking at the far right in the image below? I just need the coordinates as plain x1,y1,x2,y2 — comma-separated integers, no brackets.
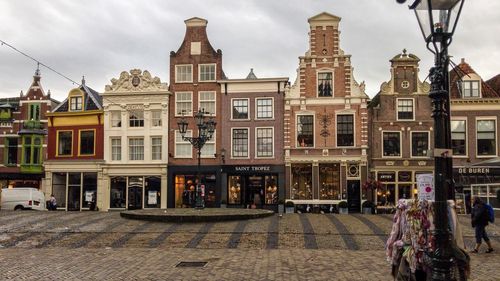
470,197,493,253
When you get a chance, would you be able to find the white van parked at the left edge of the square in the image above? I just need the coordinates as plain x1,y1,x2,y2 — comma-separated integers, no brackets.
0,187,46,210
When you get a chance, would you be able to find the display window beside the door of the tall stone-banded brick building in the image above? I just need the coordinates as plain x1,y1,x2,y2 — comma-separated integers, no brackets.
319,164,340,200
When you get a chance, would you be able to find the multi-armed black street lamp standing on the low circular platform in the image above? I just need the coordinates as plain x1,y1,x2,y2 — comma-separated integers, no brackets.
177,110,217,209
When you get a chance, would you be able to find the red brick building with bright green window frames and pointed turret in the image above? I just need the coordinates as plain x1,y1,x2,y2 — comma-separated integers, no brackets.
0,69,58,188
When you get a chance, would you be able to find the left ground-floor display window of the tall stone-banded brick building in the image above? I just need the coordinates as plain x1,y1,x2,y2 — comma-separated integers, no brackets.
290,164,312,200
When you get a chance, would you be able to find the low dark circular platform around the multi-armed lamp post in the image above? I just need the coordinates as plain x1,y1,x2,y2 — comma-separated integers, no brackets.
120,208,274,222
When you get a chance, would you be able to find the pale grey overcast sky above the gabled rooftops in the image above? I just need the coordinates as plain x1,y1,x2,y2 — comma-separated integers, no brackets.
0,0,500,101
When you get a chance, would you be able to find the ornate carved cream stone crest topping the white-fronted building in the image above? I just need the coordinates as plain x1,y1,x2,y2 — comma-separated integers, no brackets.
105,69,168,92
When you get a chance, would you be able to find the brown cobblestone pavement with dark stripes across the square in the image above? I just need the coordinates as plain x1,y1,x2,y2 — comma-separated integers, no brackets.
0,211,500,280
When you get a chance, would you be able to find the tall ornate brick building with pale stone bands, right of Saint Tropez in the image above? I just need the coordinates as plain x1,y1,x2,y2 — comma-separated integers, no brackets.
284,13,368,212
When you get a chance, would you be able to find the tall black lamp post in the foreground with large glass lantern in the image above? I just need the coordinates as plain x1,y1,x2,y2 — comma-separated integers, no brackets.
396,0,464,280
